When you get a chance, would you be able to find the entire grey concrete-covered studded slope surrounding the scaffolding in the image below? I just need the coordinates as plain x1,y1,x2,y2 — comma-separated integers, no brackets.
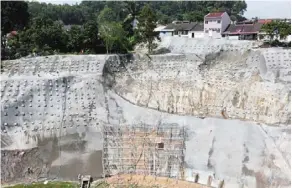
1,39,291,188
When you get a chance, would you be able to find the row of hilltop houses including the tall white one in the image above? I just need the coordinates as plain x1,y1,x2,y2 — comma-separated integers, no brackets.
155,12,291,40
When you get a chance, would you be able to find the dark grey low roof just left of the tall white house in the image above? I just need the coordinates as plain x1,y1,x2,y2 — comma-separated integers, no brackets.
163,22,204,31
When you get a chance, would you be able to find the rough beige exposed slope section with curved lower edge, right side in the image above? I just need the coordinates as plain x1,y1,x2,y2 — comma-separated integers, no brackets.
106,50,291,125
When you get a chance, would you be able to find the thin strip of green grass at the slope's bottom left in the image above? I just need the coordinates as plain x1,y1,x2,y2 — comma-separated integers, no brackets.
7,182,78,188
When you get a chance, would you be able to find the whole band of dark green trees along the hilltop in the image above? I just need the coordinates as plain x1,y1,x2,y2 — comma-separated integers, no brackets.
1,1,246,59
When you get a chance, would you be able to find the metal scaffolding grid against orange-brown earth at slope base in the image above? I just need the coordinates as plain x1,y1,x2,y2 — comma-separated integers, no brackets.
103,124,185,179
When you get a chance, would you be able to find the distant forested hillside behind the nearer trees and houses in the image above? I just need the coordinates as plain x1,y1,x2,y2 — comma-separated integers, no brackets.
28,1,247,25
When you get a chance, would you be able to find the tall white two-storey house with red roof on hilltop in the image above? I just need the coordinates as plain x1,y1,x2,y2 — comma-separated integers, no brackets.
204,12,231,38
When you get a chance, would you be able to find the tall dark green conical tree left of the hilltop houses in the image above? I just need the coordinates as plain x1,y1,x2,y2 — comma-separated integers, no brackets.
137,5,160,53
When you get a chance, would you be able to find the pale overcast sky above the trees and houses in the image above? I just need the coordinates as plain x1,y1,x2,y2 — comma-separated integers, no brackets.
39,0,291,18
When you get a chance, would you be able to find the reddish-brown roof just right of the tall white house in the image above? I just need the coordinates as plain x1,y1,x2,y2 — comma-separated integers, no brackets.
223,23,263,34
